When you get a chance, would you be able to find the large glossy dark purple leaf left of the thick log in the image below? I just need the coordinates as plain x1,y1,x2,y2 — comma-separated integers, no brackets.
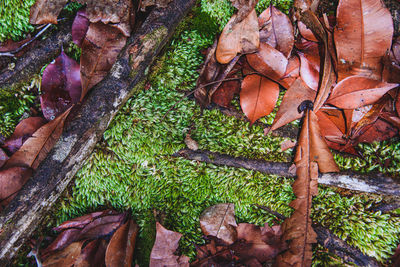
40,51,82,120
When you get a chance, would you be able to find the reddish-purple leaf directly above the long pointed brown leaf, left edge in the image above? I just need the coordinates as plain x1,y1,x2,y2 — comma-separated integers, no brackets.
0,117,46,155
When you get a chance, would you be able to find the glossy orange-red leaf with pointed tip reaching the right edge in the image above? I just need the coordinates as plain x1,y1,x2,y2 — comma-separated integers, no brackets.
327,76,398,109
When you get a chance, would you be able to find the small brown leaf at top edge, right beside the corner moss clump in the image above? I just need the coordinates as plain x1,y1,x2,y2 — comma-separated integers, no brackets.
29,0,68,24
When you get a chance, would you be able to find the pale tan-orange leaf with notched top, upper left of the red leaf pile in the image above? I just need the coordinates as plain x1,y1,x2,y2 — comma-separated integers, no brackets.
216,9,260,64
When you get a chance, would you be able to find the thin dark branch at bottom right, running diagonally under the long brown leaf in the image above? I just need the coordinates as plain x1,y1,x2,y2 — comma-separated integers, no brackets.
256,205,379,266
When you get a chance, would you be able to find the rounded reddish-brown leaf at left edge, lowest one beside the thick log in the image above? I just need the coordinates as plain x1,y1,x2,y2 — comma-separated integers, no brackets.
0,167,32,201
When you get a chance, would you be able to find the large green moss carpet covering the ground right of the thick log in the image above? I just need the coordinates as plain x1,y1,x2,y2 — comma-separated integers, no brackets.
2,0,400,266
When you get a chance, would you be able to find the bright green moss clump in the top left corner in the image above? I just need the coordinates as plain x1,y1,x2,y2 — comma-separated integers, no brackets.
0,0,35,42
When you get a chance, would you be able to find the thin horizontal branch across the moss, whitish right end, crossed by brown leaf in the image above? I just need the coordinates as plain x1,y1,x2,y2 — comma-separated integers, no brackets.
173,149,400,196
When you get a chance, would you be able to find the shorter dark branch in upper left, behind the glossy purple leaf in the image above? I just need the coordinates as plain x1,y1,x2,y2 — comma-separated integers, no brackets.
0,19,72,94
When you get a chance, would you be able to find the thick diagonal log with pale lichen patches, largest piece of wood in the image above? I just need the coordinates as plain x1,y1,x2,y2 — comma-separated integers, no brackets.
0,0,195,266
